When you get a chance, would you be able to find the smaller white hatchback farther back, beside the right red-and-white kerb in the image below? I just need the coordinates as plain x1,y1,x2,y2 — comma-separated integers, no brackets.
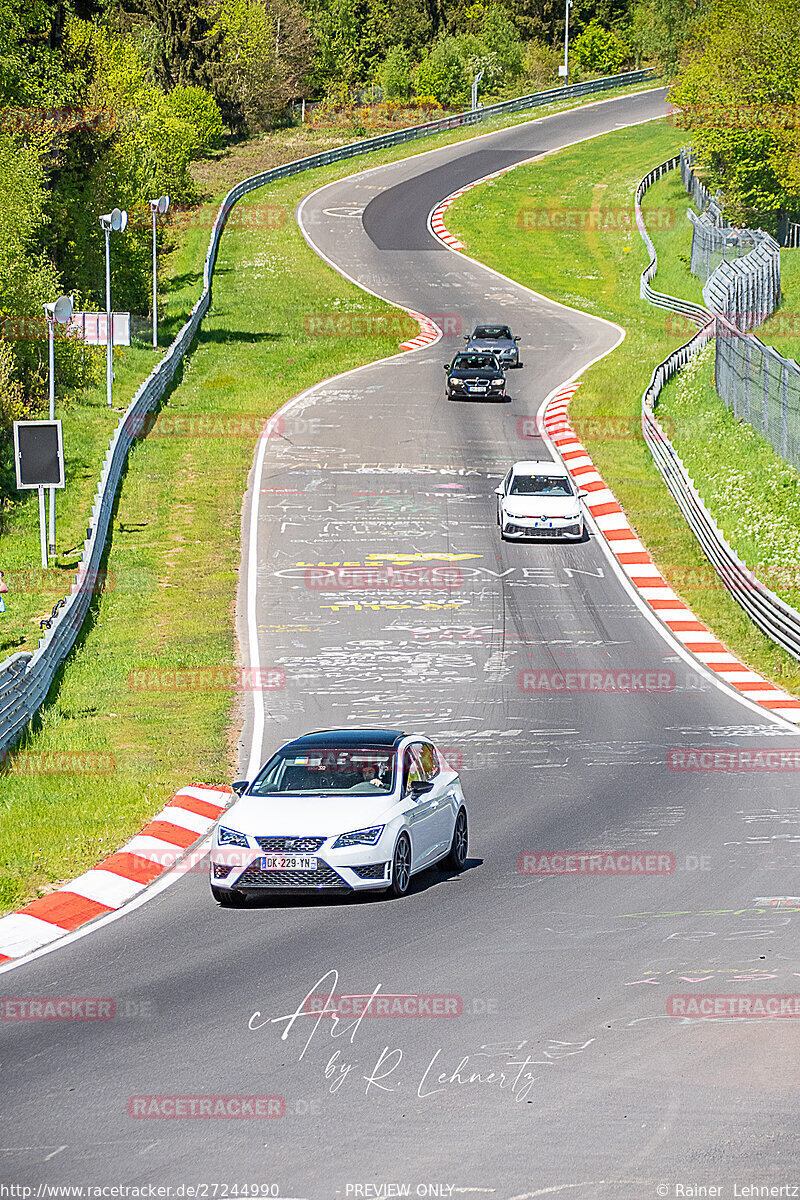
494,460,587,541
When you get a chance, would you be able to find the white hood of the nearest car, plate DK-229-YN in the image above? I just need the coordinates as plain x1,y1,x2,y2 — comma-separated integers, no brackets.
221,796,397,838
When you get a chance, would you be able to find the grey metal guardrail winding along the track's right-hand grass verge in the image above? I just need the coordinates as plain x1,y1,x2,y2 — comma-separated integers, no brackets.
634,158,800,659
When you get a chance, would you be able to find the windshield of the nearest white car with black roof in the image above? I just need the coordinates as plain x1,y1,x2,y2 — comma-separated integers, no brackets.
248,746,395,796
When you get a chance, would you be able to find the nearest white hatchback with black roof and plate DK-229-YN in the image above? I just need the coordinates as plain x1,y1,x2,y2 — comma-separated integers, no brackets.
211,728,468,906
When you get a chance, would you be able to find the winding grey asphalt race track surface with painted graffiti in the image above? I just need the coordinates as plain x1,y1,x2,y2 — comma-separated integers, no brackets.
2,84,799,1200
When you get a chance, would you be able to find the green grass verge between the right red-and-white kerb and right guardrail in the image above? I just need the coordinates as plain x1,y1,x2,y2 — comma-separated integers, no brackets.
447,121,800,692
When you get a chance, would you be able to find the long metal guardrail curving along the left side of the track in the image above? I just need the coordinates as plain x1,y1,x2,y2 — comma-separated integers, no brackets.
0,70,657,754
